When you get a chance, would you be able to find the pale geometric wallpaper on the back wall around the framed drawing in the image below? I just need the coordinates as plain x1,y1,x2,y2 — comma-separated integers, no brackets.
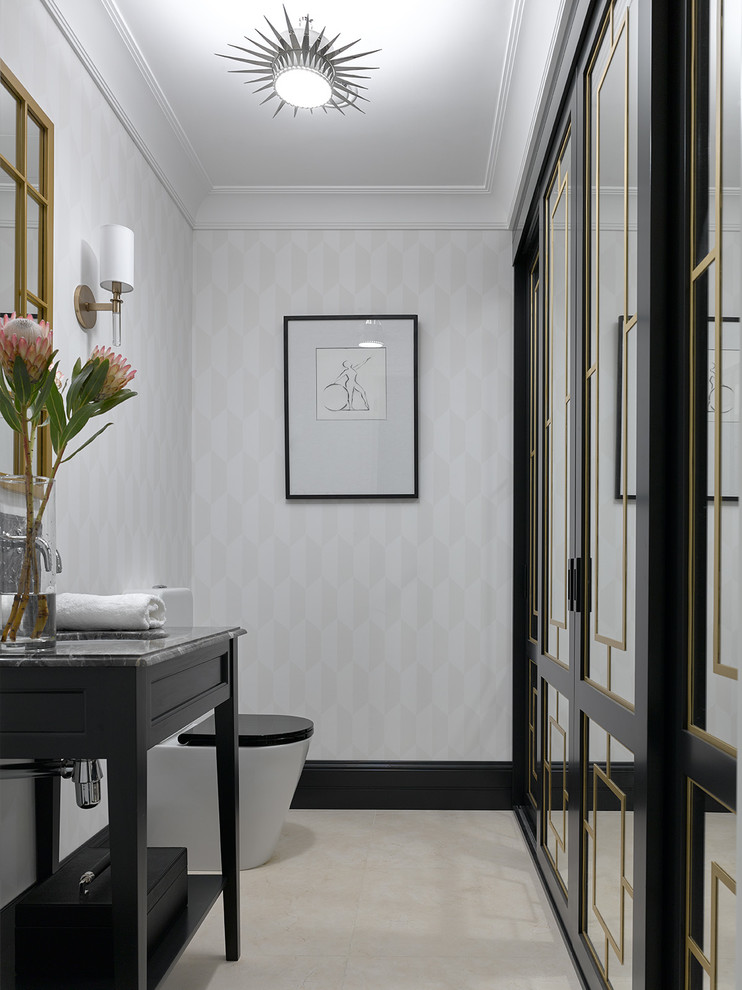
193,230,513,760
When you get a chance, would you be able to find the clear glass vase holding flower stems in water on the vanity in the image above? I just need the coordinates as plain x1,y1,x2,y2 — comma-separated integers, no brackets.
0,474,58,653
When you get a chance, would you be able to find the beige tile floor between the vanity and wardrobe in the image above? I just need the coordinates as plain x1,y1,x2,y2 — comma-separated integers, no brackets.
160,811,580,990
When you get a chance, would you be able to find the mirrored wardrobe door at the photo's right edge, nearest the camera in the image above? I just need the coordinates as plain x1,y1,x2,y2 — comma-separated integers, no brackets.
683,0,742,990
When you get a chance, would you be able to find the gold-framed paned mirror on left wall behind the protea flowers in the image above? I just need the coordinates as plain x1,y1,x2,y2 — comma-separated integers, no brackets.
0,60,54,475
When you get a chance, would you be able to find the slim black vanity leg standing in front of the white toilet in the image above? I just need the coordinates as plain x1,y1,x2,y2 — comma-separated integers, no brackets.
214,641,240,960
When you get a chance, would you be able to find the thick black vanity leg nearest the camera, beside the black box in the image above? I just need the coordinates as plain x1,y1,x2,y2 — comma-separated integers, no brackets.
107,669,147,990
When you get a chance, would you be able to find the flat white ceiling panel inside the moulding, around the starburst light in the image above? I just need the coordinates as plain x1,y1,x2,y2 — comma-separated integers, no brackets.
116,0,514,188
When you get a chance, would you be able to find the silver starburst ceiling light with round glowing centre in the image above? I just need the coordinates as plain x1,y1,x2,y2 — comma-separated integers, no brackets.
217,7,381,117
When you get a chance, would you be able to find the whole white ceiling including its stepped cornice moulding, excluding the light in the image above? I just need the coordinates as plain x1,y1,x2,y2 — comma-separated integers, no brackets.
43,0,564,227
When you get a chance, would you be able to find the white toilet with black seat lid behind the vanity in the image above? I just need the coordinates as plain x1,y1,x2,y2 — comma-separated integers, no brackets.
147,588,314,873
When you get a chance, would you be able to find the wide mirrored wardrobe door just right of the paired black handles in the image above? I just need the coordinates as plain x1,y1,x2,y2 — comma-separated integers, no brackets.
580,0,639,990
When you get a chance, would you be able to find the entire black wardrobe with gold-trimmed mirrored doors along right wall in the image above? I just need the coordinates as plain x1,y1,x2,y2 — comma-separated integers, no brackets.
515,0,742,990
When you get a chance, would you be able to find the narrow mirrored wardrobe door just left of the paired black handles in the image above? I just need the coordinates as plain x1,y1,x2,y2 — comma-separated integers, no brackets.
539,121,575,910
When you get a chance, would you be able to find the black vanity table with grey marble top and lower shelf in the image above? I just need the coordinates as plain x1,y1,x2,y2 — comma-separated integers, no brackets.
0,627,244,990
